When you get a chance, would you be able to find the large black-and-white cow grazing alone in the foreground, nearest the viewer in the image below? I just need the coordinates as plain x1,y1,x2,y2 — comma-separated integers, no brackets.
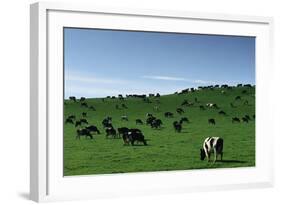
200,137,223,162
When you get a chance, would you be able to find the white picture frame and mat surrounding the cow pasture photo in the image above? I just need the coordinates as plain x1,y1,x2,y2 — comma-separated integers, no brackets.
30,2,273,202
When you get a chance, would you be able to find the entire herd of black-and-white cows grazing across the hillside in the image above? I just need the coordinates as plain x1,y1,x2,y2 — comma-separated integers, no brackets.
65,84,255,160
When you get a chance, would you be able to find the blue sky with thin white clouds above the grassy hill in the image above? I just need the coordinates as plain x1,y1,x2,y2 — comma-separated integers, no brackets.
64,28,255,98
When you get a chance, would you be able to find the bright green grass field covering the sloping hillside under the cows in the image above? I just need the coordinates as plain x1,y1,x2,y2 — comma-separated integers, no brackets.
64,87,255,176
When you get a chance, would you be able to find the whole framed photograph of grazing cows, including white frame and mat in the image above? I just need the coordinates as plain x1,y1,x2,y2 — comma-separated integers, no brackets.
30,3,273,201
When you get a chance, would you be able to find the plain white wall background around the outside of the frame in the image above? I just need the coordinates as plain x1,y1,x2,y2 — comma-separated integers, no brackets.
0,0,281,205
